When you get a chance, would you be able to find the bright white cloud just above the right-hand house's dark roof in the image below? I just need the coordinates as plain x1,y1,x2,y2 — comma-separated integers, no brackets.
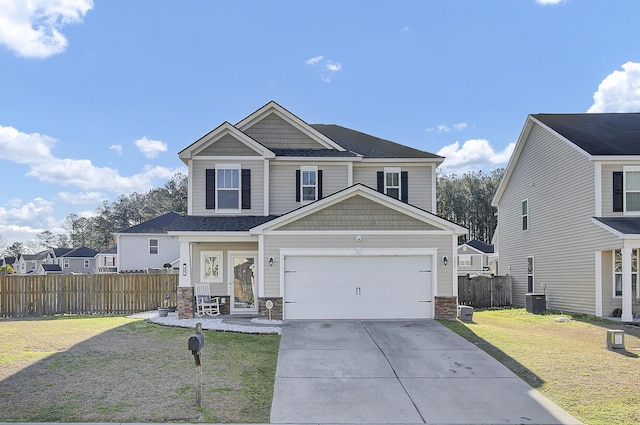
587,62,640,112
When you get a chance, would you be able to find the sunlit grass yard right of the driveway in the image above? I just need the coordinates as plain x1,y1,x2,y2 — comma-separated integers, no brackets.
441,309,640,425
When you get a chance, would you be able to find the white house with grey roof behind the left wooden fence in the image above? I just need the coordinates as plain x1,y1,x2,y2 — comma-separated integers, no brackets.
115,211,182,272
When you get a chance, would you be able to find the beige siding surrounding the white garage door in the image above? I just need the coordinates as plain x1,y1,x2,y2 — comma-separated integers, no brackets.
264,233,457,297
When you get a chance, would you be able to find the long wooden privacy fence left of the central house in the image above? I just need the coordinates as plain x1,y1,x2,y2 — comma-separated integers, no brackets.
0,274,178,317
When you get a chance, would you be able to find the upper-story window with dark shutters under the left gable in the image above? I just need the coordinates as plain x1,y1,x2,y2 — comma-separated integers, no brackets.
205,164,251,213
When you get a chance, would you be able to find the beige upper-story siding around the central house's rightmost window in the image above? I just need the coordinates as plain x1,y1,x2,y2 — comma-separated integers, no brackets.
353,163,434,212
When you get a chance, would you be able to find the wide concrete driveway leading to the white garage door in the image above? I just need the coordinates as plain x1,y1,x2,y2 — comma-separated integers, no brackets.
271,320,580,424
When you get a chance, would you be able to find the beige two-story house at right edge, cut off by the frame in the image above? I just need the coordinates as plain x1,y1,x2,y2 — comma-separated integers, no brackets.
493,113,640,322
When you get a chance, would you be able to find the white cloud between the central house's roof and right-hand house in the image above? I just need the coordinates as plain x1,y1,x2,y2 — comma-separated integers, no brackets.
438,139,515,174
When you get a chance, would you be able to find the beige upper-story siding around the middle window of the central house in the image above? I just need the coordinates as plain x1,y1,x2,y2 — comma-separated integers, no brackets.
269,161,348,215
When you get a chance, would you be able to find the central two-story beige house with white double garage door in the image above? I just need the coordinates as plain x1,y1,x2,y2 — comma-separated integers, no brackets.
169,102,466,319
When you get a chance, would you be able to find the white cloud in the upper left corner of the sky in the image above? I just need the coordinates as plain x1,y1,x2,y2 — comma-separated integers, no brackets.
0,0,93,58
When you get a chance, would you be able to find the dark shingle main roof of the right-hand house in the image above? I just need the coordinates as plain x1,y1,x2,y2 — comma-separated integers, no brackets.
531,113,640,155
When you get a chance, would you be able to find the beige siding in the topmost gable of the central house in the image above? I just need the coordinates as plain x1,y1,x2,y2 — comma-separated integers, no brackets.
244,113,325,149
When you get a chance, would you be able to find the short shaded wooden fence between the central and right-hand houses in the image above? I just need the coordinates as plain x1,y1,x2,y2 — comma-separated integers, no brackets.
458,276,511,308
